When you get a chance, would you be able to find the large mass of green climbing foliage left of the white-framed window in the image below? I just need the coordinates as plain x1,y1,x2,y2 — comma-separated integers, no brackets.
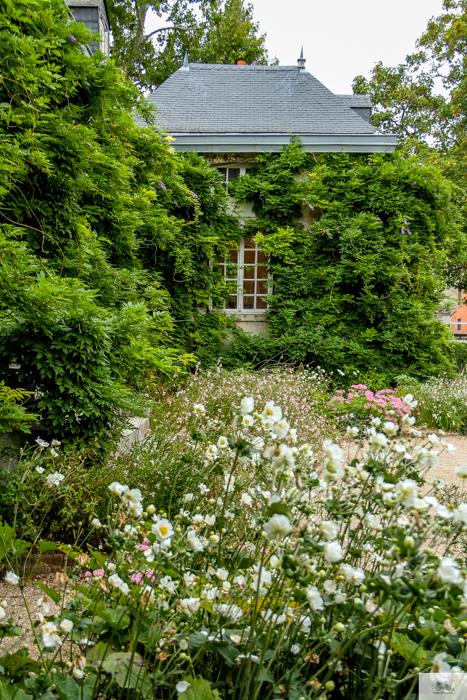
0,0,238,450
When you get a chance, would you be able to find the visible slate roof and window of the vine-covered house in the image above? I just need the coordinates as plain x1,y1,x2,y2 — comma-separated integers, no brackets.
142,50,397,333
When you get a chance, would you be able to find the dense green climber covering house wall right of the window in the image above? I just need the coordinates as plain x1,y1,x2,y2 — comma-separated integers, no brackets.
233,144,465,381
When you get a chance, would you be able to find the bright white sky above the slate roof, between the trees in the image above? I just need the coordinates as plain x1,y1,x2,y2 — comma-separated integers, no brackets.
146,0,448,94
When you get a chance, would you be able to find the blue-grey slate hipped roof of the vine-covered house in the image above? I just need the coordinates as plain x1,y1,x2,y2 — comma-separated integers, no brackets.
149,63,376,136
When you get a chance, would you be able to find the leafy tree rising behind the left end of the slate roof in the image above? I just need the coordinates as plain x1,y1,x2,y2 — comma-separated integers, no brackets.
108,0,268,90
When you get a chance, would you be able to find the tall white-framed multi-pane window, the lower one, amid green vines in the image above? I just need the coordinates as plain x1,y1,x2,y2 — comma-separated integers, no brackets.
219,238,270,313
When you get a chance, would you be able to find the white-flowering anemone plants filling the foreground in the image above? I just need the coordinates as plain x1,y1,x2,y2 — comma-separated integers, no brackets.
0,397,467,700
